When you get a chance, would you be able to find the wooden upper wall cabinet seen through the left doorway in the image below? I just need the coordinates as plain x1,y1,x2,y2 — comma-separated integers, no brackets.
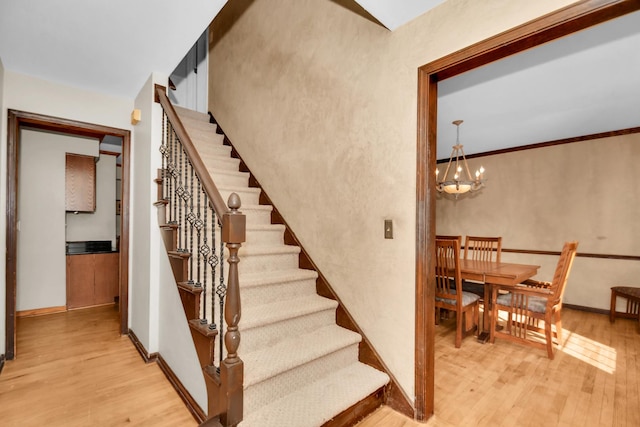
65,154,96,212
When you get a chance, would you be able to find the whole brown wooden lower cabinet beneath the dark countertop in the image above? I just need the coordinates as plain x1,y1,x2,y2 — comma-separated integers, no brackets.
67,252,120,309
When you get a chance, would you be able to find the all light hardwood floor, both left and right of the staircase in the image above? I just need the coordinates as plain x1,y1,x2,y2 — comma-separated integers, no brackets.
0,306,640,427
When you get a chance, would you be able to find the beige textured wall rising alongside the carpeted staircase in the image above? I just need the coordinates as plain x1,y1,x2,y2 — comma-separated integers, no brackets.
209,0,572,402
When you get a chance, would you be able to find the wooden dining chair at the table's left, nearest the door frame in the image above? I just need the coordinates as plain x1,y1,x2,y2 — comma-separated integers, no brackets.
435,239,480,348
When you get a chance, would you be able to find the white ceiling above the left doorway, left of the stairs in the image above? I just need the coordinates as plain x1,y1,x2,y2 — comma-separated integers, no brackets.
0,0,226,98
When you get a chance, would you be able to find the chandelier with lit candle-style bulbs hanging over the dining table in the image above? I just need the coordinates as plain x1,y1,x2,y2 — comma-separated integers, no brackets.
436,120,485,198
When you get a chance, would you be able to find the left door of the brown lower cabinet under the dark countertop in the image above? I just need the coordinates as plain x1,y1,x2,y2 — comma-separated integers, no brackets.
67,255,94,308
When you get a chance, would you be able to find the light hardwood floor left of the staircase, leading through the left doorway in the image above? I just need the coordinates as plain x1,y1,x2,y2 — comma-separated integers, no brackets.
0,306,198,427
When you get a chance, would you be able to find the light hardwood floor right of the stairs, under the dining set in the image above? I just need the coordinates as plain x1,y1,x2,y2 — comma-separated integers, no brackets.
358,308,640,427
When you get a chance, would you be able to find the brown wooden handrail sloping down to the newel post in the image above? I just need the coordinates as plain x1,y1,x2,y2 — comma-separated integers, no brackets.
155,85,230,218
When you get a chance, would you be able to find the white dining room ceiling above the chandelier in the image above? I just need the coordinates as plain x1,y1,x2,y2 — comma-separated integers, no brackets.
437,12,640,159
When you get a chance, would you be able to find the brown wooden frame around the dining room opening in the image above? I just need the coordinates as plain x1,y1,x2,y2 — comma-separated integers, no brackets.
414,0,640,421
